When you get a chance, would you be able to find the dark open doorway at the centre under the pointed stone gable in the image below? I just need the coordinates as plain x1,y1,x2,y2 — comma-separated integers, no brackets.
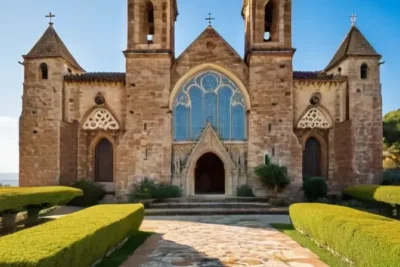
195,153,225,195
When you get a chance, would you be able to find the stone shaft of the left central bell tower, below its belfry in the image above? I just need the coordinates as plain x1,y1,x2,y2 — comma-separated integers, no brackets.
116,54,172,199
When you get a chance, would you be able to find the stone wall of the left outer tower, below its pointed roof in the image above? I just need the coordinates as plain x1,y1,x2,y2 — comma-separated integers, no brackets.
19,58,65,186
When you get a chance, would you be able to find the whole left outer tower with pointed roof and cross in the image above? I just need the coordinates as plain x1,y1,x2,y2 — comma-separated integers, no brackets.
19,18,84,186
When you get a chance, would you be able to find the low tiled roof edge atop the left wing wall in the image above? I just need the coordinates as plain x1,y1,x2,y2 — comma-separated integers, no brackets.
64,72,126,82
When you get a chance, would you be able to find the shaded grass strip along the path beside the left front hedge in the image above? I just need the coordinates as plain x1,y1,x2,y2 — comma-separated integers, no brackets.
96,231,153,267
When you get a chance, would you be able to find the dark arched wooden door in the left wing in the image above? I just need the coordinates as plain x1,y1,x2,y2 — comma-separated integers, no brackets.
94,138,114,183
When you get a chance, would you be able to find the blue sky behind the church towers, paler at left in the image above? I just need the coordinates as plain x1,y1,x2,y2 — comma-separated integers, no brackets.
0,0,400,172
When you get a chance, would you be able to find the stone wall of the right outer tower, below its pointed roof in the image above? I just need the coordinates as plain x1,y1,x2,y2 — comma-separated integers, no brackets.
340,57,383,184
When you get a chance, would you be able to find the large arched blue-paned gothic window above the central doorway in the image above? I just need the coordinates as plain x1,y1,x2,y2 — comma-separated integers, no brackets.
173,71,246,141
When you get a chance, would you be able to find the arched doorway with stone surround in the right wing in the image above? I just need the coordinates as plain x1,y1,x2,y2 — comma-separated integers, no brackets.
301,129,329,179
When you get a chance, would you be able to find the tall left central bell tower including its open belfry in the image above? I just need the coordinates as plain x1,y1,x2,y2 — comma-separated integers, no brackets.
117,0,178,195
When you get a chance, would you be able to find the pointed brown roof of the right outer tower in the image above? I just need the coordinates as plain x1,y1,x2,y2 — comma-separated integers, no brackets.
325,25,380,71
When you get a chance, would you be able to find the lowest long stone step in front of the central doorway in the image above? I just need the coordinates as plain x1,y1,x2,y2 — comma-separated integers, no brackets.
145,207,289,216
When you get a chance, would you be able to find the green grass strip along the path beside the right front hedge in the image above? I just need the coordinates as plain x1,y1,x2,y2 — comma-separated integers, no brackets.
271,223,349,267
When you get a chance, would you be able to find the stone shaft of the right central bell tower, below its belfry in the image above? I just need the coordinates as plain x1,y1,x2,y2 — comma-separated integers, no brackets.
248,53,302,195
